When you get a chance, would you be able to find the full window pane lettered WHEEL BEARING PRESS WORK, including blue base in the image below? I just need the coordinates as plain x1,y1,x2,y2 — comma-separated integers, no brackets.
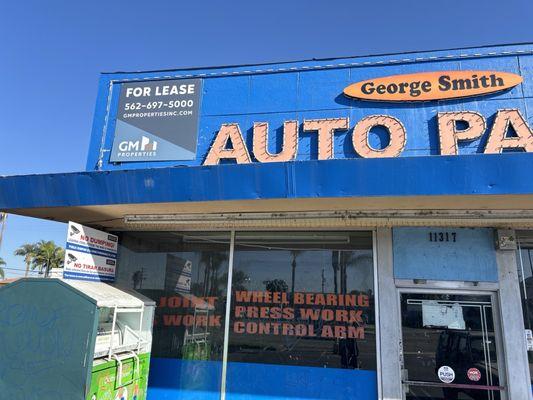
227,232,377,399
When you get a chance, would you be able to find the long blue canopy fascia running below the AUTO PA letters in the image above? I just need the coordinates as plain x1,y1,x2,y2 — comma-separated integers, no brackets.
0,153,533,210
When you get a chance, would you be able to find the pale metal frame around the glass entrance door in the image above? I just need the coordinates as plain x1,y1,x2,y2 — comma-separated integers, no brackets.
396,281,508,400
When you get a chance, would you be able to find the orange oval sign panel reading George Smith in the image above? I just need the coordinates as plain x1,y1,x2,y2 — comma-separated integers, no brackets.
344,71,522,101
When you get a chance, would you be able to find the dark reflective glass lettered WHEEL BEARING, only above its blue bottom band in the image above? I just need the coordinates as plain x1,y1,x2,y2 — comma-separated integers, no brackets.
229,232,376,370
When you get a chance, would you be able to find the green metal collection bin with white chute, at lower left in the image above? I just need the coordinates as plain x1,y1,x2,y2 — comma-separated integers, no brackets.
0,278,155,400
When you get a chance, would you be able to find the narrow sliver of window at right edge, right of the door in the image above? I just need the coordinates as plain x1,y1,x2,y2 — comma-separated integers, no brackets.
516,231,533,388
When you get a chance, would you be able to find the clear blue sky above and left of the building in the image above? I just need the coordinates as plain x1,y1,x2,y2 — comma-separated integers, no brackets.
0,0,533,276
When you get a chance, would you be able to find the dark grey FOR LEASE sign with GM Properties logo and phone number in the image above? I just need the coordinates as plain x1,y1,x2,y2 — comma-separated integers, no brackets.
110,79,202,162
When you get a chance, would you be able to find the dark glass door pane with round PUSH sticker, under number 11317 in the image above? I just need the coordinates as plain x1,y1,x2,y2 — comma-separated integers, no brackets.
400,293,504,400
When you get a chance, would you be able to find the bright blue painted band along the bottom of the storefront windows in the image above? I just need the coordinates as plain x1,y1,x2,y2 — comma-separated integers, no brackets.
148,358,377,400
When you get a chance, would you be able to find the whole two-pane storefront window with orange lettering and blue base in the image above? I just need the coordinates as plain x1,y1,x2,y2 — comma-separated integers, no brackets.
117,232,377,400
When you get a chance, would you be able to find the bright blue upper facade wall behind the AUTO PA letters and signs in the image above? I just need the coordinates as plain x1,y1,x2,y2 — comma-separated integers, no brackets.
87,45,533,170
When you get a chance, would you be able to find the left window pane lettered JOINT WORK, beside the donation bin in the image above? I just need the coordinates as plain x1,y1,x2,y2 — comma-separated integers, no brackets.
117,232,230,399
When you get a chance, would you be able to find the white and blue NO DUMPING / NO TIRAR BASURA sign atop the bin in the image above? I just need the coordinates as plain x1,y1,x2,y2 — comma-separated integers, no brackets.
63,221,118,282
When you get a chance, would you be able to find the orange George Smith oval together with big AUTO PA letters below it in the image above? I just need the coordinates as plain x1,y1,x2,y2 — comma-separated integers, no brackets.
203,71,533,165
